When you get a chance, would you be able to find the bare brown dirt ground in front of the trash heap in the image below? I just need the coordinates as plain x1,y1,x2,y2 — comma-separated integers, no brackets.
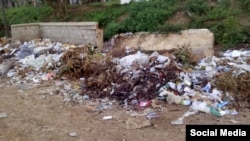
0,79,250,141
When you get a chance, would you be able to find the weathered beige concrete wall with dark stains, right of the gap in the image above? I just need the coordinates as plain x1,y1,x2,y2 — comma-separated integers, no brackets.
117,29,214,58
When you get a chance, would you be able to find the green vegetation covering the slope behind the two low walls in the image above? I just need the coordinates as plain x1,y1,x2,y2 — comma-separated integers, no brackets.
0,0,250,48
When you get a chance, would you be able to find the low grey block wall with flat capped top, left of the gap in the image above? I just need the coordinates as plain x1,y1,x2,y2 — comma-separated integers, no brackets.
11,22,103,48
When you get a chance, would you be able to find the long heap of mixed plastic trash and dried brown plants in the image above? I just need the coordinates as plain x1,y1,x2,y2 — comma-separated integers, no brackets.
0,39,250,118
